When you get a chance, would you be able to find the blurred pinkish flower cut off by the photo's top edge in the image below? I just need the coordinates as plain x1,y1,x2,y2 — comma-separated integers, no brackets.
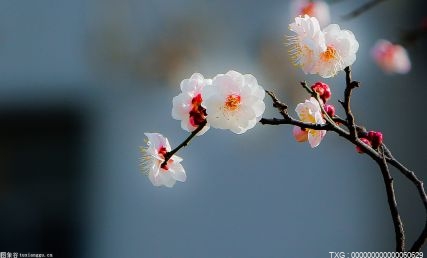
291,0,331,27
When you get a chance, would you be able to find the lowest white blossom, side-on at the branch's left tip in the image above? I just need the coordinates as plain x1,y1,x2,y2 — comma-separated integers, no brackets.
140,133,187,187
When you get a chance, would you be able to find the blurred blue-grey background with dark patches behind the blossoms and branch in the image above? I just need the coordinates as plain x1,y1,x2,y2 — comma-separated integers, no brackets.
0,0,427,258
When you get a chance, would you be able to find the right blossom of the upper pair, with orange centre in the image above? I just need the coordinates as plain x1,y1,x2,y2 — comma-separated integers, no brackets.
316,24,359,78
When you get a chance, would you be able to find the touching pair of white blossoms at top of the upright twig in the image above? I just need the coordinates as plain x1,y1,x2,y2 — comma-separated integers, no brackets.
289,15,359,78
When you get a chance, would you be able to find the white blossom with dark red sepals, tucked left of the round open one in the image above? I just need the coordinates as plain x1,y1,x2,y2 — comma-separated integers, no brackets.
172,73,212,135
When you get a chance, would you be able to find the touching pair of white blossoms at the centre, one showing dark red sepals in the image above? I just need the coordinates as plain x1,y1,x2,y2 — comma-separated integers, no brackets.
172,71,265,135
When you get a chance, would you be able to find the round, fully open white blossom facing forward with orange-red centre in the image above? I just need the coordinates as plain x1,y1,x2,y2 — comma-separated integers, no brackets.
202,71,265,134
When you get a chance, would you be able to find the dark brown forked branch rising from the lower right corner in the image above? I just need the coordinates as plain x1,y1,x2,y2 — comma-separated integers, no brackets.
260,67,427,252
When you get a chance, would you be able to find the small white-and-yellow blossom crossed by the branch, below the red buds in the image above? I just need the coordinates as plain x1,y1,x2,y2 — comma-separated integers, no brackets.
293,97,326,148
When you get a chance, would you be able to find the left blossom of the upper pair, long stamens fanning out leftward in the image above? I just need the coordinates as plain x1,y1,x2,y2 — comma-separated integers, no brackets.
288,15,326,74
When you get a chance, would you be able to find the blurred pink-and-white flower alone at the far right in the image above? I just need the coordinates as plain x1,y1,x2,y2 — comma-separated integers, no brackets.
371,40,411,74
